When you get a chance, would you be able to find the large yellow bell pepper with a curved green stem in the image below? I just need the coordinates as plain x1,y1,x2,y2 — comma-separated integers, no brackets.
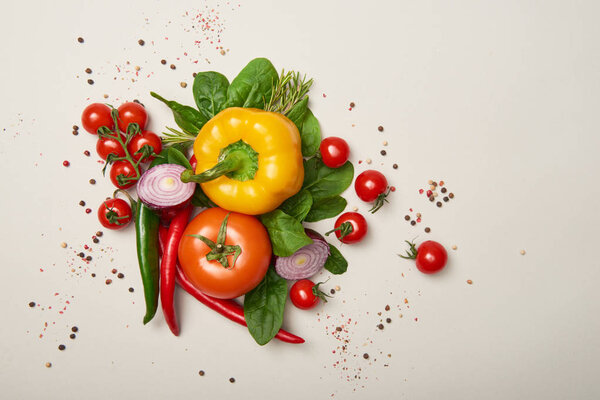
181,107,304,215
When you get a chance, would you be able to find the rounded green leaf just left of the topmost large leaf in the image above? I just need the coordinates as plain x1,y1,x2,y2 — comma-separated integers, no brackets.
192,71,229,119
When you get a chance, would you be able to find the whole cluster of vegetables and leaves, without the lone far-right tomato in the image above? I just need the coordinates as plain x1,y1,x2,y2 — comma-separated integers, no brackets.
82,58,406,345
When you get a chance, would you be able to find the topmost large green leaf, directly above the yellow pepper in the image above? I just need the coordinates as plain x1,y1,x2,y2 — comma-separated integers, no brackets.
227,58,279,109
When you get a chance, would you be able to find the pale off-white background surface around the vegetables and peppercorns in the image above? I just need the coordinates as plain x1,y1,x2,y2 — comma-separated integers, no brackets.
0,1,600,399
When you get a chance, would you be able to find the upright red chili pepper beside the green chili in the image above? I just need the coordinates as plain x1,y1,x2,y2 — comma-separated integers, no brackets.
159,206,192,336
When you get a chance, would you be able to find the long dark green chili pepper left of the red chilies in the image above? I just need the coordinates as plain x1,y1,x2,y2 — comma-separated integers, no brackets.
135,201,160,325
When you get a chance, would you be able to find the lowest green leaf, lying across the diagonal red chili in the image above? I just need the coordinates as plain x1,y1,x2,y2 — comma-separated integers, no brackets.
244,268,287,346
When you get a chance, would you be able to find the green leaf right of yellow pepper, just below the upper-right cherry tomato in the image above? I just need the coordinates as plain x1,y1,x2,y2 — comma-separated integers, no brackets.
302,157,354,203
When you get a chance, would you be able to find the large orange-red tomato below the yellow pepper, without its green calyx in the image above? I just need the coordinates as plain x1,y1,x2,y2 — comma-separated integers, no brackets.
178,207,271,299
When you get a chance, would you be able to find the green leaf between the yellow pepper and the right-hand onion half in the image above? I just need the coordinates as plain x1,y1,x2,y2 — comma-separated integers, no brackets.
260,209,312,257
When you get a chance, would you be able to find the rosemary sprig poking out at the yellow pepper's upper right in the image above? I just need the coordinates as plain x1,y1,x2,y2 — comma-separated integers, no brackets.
265,70,313,115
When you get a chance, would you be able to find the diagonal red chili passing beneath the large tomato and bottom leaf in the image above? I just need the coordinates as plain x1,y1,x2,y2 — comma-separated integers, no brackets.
172,258,304,343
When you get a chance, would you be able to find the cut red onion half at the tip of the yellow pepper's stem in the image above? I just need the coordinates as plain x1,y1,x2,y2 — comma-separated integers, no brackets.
137,164,196,211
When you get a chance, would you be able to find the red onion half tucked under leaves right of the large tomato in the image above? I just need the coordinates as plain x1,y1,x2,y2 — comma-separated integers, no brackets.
275,229,329,280
